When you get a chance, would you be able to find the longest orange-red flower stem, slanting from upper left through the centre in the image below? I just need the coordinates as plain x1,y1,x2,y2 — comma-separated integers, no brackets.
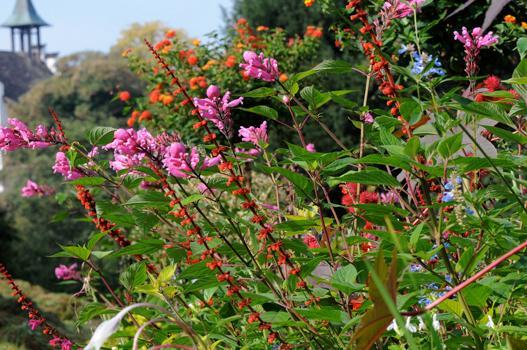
145,39,319,303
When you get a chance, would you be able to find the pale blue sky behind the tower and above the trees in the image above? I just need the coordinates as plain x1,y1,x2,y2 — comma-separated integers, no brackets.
0,0,232,55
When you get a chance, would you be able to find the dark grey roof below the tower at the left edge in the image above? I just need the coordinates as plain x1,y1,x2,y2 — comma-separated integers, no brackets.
0,51,52,100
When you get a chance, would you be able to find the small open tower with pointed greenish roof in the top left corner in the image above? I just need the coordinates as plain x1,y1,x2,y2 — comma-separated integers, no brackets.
2,0,49,59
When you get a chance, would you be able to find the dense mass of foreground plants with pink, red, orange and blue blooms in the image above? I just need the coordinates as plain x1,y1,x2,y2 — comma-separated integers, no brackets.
0,0,527,350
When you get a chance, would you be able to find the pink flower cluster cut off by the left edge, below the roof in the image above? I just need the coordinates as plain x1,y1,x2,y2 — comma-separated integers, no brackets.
0,119,51,151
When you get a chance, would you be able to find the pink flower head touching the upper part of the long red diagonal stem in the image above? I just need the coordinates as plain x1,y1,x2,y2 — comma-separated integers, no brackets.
194,85,243,138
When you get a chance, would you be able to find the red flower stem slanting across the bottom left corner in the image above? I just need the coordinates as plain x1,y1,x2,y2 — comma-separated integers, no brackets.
0,263,73,350
